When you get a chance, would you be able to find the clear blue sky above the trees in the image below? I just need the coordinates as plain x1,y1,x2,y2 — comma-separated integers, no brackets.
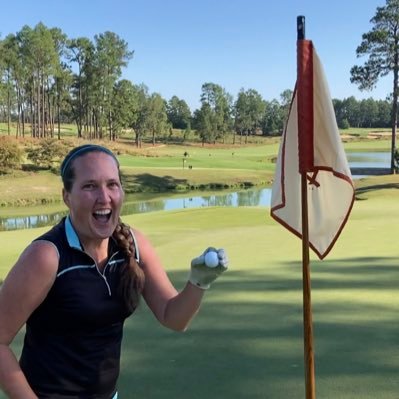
0,0,392,110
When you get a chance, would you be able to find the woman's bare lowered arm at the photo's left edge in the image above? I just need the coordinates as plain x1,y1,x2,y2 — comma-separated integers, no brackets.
0,241,58,399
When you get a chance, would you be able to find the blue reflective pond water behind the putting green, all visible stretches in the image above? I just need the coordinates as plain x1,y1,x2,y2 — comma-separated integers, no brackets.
0,152,390,231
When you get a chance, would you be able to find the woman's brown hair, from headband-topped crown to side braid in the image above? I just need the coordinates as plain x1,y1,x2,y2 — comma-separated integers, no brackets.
61,144,145,312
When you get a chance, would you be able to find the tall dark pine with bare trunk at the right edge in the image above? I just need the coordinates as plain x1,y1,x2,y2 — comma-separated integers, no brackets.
351,0,399,173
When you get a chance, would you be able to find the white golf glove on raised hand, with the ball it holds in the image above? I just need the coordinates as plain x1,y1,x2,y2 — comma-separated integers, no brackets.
188,247,229,290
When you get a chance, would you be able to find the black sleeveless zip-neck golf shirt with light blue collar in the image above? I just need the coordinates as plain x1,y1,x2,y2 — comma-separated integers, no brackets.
20,217,138,399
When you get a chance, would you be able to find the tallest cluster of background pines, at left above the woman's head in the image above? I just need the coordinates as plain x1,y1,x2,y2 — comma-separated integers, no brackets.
0,23,133,140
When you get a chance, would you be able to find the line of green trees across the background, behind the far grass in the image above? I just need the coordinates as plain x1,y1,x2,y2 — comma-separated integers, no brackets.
0,23,392,146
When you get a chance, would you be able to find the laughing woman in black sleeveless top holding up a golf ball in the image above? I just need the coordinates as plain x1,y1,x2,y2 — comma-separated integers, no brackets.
0,144,227,399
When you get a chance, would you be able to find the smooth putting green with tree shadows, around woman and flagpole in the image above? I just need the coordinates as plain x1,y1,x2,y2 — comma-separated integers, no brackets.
0,190,399,399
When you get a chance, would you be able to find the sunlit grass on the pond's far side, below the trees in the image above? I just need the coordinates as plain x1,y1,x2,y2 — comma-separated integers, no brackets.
0,131,390,206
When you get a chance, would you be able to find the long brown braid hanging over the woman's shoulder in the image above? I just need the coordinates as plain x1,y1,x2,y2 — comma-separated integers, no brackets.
113,219,145,311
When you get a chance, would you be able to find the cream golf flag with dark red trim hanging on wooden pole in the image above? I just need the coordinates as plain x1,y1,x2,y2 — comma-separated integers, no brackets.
271,40,354,259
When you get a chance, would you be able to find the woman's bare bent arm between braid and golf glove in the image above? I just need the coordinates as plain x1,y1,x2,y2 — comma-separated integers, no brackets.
134,230,204,331
